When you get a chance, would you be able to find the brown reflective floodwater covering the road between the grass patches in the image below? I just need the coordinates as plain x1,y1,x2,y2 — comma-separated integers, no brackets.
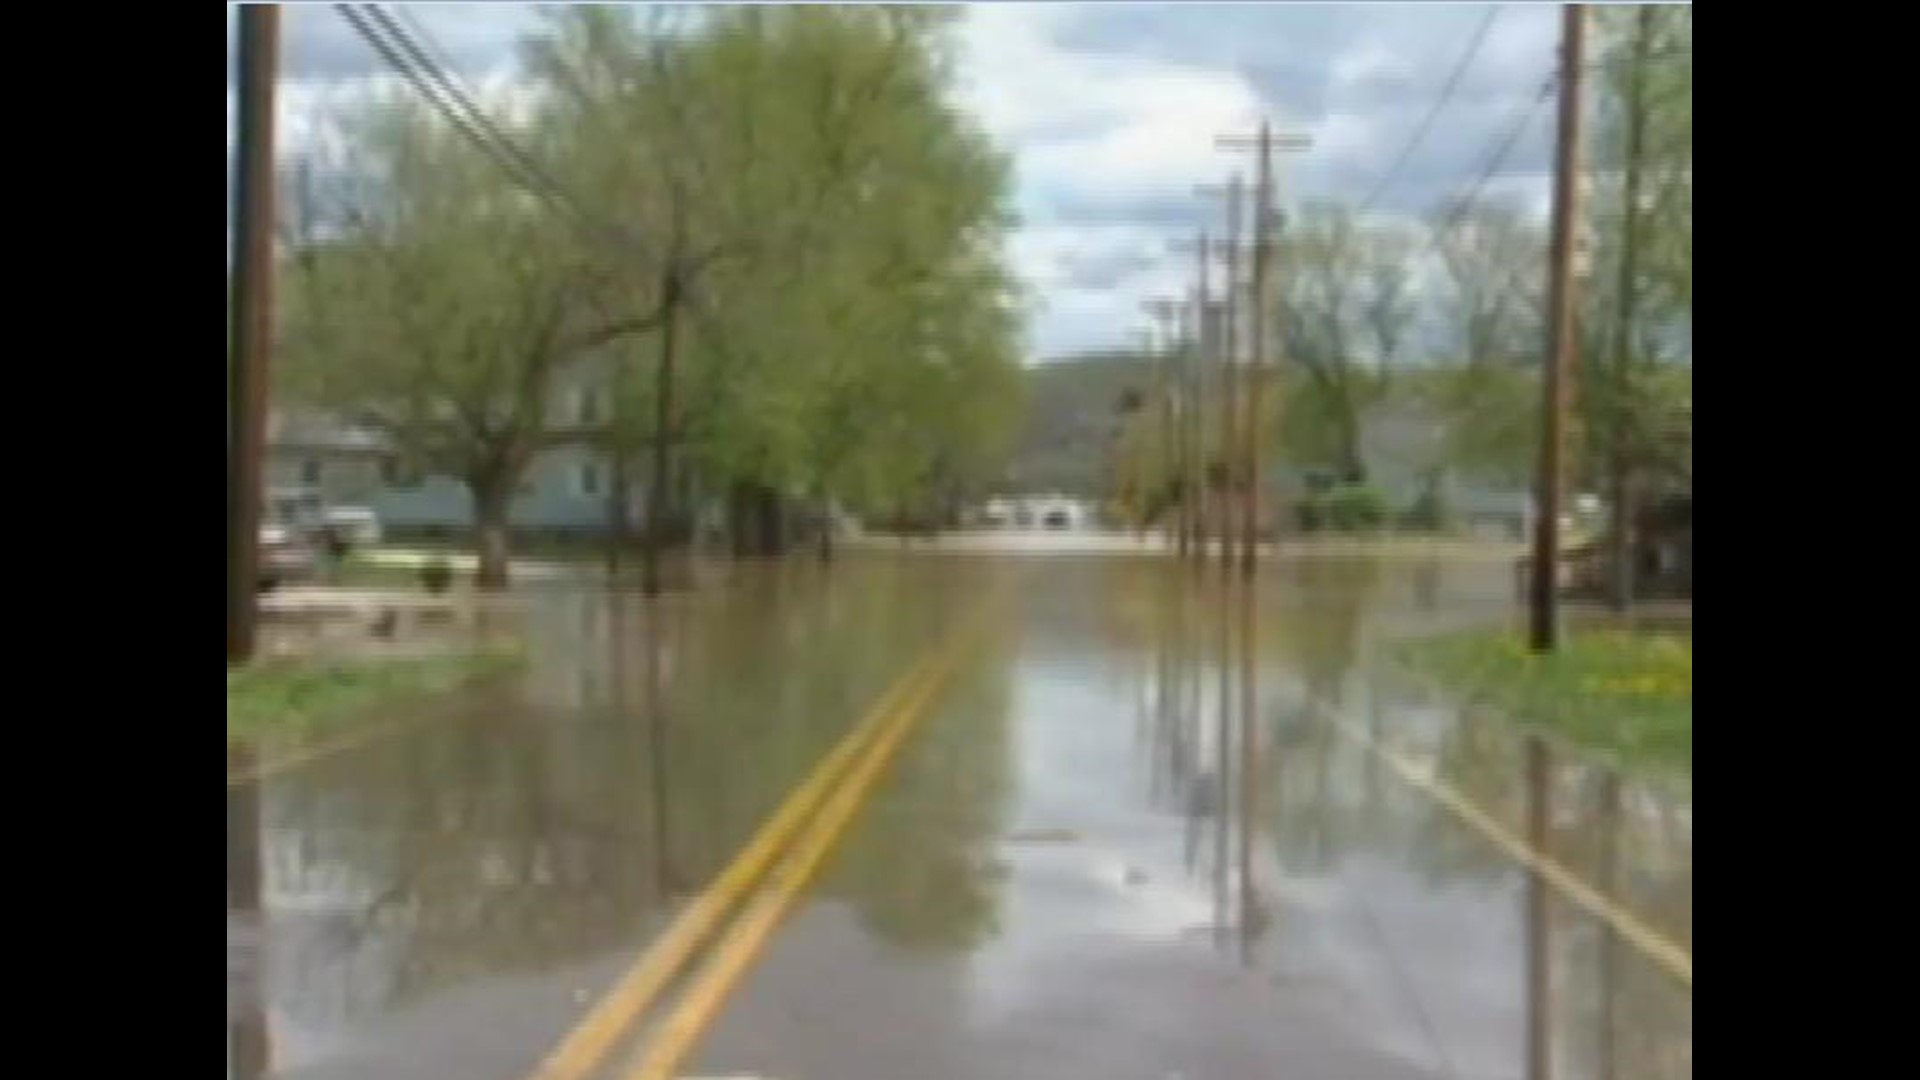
227,550,1692,1080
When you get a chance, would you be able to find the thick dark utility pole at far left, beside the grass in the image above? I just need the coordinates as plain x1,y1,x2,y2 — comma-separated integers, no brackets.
227,4,280,665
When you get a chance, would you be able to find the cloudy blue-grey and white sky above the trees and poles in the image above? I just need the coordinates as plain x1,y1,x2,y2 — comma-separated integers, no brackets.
227,2,1559,359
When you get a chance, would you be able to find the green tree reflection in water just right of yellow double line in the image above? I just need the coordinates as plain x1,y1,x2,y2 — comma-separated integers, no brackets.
837,630,1012,949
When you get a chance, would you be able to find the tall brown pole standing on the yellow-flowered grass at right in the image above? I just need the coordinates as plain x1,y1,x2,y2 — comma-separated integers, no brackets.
1528,4,1586,653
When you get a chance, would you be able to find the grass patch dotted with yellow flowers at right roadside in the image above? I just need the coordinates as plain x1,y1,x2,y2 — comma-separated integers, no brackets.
1404,630,1693,773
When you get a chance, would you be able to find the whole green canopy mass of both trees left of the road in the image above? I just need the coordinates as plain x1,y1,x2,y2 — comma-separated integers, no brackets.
286,8,1023,541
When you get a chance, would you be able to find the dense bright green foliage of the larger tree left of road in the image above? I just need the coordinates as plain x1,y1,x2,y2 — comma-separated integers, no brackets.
530,8,1021,509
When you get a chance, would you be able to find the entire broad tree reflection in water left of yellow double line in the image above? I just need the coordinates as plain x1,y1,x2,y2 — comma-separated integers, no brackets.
269,557,975,1011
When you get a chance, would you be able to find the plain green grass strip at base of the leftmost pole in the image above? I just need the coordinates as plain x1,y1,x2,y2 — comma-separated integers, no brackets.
227,650,522,742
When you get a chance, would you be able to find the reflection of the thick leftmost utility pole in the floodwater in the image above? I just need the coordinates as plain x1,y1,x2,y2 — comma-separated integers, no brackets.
227,746,273,1080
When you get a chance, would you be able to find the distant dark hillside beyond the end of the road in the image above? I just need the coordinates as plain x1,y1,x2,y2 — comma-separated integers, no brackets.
1008,354,1152,496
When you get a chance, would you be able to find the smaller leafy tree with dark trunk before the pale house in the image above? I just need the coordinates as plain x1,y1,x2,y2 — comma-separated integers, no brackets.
282,100,649,588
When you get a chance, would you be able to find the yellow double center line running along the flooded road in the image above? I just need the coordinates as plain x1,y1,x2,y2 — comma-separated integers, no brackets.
532,591,985,1080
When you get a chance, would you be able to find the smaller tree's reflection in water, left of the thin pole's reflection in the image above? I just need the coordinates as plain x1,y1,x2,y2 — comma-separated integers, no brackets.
263,703,657,1009
